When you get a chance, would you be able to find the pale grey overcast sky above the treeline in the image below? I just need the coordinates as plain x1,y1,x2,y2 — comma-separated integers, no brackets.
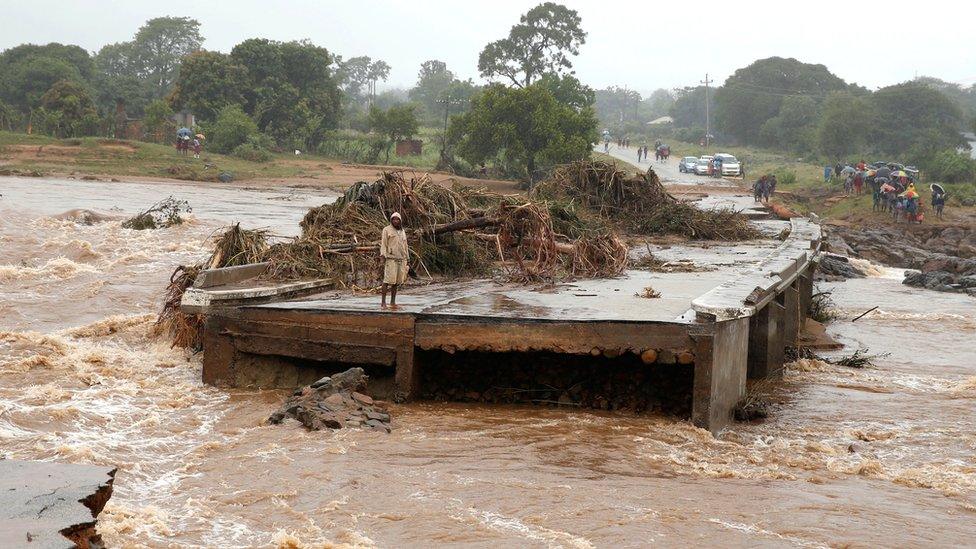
0,0,976,92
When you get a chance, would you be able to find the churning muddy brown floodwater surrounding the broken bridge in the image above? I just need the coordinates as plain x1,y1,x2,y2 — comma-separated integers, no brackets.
0,178,976,547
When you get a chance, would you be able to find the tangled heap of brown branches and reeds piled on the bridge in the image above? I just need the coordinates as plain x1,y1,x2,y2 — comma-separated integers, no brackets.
158,161,758,347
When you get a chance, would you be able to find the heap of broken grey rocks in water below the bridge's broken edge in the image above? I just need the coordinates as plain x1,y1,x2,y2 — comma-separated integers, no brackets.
268,368,390,433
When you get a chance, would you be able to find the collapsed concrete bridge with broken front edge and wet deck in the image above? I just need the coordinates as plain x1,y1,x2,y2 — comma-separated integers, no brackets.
183,215,822,432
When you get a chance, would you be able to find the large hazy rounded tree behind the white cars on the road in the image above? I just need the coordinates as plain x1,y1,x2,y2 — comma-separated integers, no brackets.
714,57,848,144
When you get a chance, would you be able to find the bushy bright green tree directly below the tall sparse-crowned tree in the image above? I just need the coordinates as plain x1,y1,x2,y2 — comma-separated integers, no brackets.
449,84,598,184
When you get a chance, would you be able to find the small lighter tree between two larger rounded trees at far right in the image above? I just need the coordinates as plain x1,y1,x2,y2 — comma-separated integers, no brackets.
816,92,875,160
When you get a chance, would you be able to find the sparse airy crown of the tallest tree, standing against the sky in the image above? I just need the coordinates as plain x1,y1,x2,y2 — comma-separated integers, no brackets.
478,2,586,87
